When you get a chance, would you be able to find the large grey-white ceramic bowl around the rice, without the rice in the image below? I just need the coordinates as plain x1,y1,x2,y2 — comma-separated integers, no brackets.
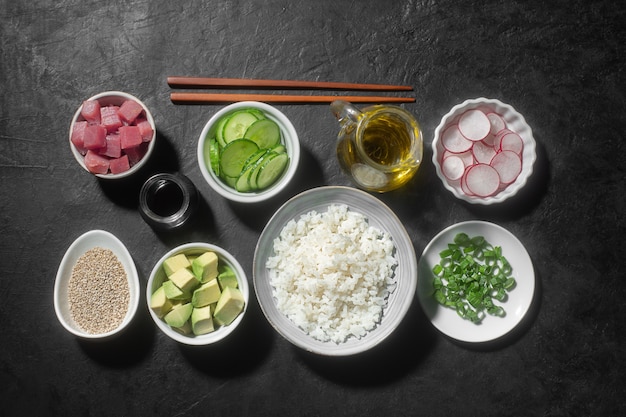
253,186,417,356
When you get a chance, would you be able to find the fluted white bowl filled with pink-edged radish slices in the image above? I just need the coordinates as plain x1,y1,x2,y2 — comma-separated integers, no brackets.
432,97,537,205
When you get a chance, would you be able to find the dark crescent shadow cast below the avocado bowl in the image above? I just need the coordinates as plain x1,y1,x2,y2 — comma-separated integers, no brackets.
179,297,274,378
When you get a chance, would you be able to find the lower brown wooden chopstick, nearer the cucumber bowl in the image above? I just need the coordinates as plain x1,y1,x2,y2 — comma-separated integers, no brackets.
170,93,415,104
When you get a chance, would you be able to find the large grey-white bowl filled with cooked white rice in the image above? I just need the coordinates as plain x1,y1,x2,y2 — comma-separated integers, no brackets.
253,186,417,356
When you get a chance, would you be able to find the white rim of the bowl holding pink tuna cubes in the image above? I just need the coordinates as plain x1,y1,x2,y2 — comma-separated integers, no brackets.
69,90,156,180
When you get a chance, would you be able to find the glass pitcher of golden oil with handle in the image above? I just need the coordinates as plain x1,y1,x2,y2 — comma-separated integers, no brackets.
330,100,423,193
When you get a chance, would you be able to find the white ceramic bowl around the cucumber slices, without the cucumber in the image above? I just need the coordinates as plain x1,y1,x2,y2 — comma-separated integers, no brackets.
198,101,300,203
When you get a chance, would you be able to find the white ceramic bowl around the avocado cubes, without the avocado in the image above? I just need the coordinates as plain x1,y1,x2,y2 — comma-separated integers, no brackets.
146,242,249,345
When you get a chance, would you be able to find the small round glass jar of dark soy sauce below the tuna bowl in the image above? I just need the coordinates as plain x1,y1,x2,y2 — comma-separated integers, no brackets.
139,173,198,231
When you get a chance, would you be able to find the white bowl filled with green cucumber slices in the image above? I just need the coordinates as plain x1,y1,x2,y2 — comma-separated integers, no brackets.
198,101,300,203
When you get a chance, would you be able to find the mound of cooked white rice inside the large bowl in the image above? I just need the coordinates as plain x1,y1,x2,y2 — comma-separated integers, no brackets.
266,204,398,343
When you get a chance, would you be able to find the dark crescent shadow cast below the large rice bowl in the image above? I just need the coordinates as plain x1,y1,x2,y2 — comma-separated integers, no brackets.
297,298,436,386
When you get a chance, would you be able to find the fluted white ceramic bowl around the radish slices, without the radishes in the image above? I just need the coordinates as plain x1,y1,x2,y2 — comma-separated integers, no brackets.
432,97,537,205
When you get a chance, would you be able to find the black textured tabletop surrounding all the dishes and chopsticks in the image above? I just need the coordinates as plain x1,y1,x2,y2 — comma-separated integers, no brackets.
0,0,626,416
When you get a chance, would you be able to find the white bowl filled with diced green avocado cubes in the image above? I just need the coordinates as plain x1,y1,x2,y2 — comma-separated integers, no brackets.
146,242,249,345
